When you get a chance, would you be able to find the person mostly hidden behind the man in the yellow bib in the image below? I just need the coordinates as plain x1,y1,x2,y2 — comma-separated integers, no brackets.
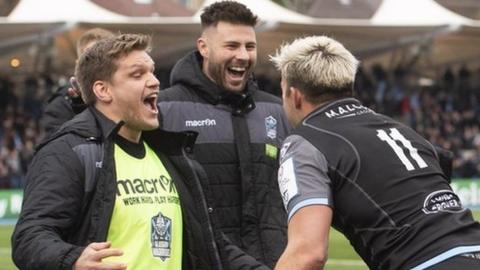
41,28,114,137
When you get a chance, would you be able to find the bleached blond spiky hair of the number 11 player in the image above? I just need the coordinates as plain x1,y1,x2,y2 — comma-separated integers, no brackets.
270,36,358,103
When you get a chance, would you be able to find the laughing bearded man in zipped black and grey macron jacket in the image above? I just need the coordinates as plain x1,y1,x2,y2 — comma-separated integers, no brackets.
159,1,289,266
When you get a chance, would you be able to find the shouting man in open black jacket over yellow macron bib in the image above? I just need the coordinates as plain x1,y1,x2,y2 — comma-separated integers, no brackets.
12,34,266,270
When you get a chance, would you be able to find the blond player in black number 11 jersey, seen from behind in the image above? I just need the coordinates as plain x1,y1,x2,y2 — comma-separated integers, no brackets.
272,36,480,270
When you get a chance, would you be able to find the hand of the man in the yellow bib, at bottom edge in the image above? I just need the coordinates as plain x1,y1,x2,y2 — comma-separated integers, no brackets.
73,242,127,270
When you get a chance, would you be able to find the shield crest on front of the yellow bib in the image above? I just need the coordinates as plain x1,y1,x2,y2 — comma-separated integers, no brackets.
151,212,172,261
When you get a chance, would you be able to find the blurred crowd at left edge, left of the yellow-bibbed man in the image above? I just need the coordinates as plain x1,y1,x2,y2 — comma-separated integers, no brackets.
0,76,55,188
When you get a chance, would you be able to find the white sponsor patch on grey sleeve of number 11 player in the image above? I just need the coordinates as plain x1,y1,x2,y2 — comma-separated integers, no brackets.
278,158,298,208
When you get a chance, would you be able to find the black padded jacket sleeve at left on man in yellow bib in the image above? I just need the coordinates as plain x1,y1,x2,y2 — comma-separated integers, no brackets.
12,141,84,270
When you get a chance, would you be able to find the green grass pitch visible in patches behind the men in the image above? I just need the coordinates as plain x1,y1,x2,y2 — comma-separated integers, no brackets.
0,211,480,270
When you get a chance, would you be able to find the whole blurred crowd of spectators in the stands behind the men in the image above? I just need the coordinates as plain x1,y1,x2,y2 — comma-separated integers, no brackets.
0,65,480,189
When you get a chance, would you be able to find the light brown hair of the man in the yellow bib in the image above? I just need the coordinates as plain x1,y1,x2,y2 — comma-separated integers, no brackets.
75,34,151,105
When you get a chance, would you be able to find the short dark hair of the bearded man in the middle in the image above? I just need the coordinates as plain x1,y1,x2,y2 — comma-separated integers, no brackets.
200,1,258,29
